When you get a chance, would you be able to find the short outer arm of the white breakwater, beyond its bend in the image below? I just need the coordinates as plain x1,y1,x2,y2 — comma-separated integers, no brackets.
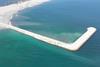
72,27,96,50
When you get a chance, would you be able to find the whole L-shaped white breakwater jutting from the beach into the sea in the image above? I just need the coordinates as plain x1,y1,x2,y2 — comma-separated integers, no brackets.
9,25,96,51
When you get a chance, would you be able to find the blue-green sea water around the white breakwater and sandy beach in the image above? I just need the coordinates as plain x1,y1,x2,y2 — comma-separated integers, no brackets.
0,0,100,67
